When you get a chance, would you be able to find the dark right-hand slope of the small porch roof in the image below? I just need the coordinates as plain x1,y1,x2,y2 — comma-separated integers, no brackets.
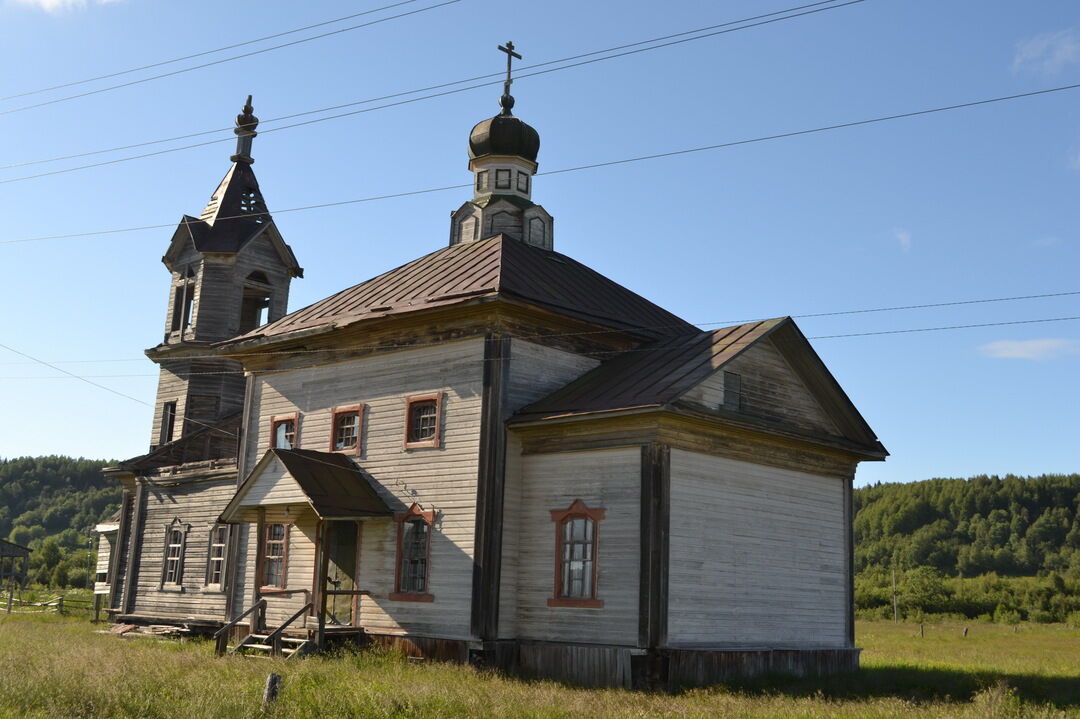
261,449,393,517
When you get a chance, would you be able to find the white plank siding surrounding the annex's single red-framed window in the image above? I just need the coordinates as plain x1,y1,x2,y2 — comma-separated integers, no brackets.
505,447,642,646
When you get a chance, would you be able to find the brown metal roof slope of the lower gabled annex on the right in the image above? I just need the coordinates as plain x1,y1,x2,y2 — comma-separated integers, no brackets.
511,317,791,422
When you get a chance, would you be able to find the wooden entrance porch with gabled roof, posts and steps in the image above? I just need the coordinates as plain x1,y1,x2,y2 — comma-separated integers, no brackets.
216,449,393,656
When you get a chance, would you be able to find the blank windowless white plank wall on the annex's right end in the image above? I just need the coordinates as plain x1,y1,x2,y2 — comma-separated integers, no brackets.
667,449,847,648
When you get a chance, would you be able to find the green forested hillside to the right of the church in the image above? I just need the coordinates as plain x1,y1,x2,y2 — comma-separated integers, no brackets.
853,474,1080,624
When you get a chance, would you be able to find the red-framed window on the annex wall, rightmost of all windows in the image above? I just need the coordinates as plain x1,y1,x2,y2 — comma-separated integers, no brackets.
548,500,605,609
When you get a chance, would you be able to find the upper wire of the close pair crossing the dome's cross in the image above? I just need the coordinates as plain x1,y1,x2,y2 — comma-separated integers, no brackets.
0,0,848,170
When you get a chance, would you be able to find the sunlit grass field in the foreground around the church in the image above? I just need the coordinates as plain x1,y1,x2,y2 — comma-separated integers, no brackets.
0,614,1080,719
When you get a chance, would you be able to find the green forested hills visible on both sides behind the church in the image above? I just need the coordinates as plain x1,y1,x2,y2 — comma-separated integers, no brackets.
0,457,1080,625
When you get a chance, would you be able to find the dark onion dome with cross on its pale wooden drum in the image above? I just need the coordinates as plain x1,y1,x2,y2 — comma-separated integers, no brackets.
450,42,554,249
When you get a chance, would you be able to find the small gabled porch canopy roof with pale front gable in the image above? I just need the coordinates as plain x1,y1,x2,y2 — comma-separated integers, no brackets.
220,449,393,524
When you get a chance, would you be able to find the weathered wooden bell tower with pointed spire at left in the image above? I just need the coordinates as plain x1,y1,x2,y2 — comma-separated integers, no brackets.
146,95,303,451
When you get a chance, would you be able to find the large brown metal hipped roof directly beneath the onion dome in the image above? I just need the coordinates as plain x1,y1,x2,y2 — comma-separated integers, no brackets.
231,234,696,342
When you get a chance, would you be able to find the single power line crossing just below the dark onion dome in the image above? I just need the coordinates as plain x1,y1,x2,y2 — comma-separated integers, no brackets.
8,76,1080,244
